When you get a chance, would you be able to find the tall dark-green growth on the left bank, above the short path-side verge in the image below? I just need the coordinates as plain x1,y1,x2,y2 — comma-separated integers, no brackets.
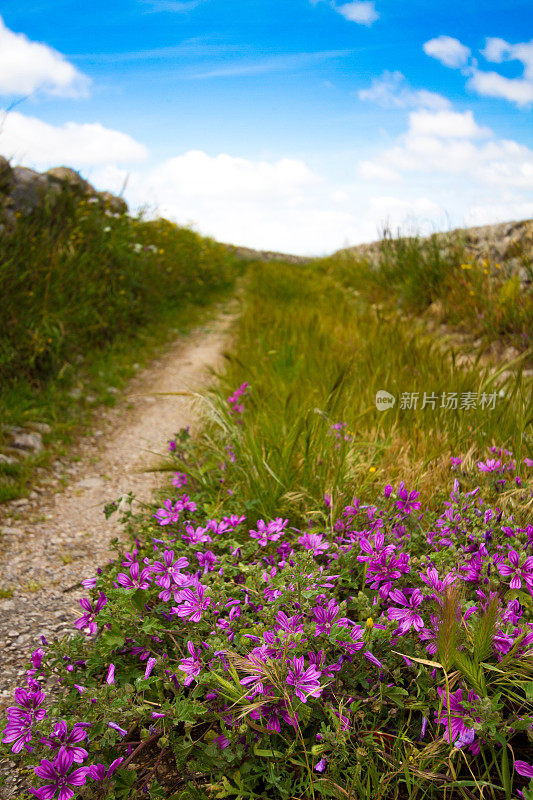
0,189,240,383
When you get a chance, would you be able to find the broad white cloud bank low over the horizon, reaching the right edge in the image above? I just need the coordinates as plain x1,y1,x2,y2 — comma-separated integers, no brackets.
91,128,533,255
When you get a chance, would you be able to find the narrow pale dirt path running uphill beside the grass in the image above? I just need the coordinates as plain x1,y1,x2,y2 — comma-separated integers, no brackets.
0,310,234,711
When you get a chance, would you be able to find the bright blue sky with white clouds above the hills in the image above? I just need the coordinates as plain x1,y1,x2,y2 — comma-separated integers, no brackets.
0,0,533,254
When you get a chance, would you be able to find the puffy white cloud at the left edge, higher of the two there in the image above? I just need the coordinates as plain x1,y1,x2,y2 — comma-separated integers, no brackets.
0,17,90,97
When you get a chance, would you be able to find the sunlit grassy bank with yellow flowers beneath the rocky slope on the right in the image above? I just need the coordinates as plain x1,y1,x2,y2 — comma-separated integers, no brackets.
318,225,533,351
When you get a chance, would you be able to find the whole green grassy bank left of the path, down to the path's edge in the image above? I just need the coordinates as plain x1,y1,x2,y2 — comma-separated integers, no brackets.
0,184,242,502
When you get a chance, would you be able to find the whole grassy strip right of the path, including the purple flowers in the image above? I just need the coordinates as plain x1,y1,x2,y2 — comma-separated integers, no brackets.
4,252,533,800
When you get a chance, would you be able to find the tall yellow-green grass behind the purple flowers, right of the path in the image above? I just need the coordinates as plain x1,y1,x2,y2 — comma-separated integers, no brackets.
189,256,533,519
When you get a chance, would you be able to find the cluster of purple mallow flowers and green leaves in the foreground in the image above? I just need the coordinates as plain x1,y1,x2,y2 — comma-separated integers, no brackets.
3,432,533,800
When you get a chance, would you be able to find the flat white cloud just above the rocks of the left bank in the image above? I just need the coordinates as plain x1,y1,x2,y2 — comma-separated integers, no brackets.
0,111,147,169
